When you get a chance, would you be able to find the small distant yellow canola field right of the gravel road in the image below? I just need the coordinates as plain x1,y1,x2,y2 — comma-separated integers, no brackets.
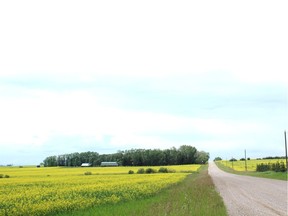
217,159,286,171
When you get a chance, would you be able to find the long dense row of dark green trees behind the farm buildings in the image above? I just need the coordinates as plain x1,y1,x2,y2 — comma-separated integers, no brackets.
43,145,209,167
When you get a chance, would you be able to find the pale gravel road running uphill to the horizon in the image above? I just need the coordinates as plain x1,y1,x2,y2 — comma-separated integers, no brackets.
209,163,288,216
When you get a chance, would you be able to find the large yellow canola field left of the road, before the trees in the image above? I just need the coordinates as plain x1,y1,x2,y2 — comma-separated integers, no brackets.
0,165,200,216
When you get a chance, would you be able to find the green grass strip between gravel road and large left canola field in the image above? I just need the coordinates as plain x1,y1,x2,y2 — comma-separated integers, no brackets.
59,165,227,216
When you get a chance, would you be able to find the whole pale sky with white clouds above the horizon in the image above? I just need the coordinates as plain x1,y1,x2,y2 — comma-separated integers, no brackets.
0,0,288,165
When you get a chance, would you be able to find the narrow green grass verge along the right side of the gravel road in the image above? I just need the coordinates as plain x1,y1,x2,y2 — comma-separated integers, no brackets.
216,162,287,181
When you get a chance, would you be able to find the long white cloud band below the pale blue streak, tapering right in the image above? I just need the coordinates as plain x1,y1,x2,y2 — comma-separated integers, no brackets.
0,83,282,145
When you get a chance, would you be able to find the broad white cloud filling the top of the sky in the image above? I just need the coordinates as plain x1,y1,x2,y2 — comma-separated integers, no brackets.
0,1,288,81
